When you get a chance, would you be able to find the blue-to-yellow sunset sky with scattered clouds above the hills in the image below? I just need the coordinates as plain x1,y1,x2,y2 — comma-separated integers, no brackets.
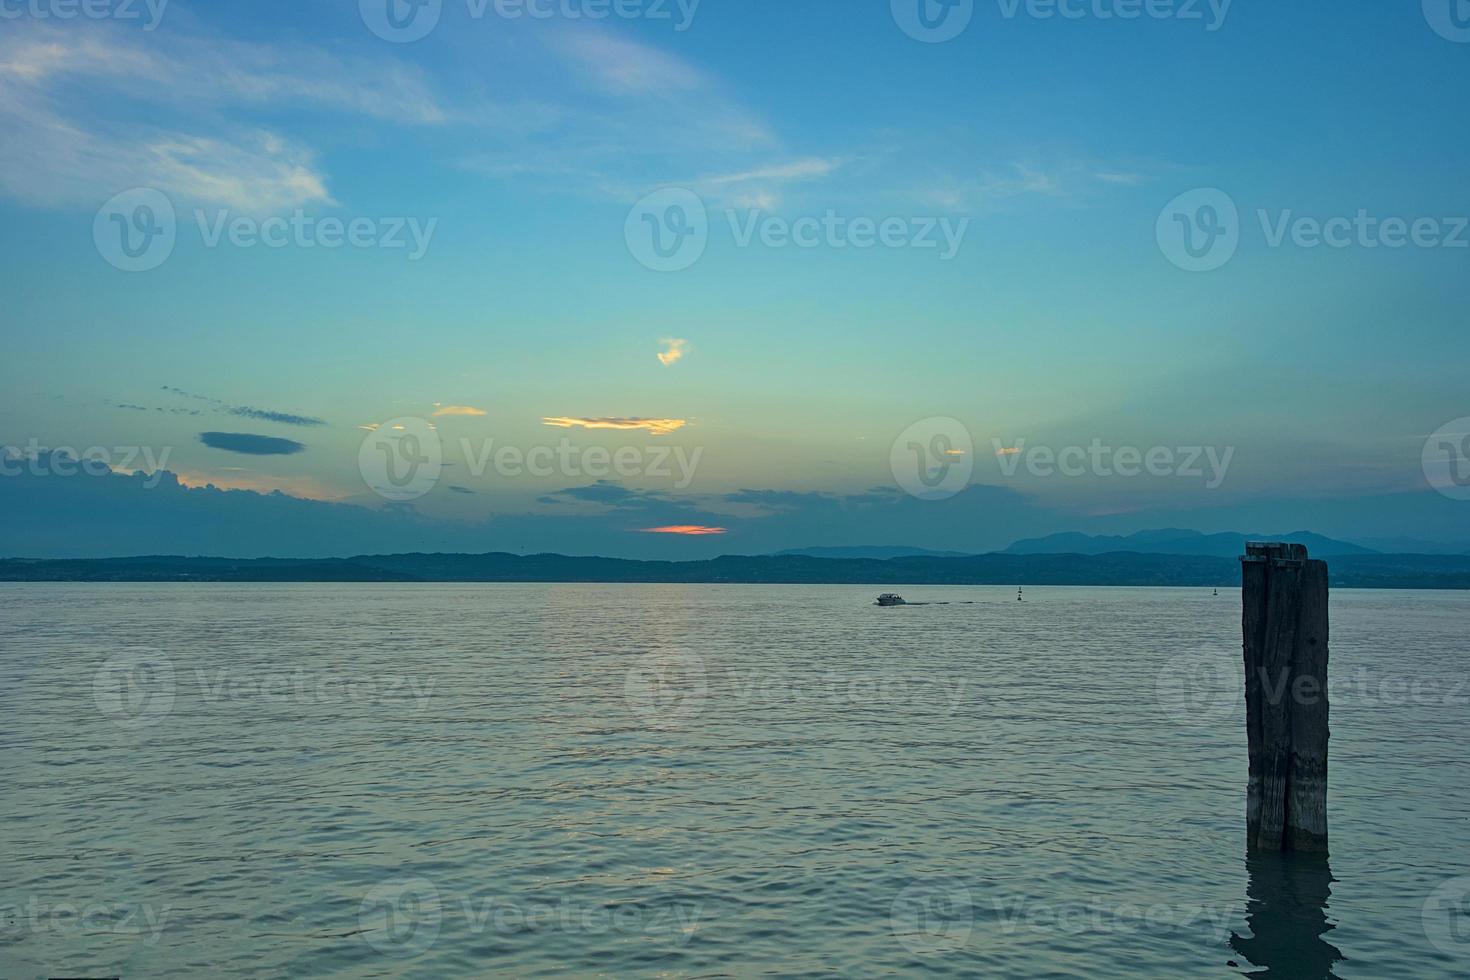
0,0,1470,558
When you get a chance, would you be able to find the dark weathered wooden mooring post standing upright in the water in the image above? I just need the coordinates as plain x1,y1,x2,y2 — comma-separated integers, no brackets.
1241,542,1329,854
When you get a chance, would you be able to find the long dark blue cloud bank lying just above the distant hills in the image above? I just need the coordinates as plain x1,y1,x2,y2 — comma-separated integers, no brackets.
0,461,1470,560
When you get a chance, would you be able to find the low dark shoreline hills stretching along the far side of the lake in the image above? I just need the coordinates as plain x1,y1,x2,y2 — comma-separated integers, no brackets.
11,551,1470,589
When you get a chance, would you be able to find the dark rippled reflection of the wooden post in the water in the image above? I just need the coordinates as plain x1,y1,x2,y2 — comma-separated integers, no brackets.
1230,852,1345,980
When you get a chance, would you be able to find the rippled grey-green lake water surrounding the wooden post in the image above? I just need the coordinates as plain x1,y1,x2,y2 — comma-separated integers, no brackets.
0,583,1470,980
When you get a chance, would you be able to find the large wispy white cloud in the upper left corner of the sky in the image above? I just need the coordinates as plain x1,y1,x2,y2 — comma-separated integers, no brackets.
0,21,444,212
